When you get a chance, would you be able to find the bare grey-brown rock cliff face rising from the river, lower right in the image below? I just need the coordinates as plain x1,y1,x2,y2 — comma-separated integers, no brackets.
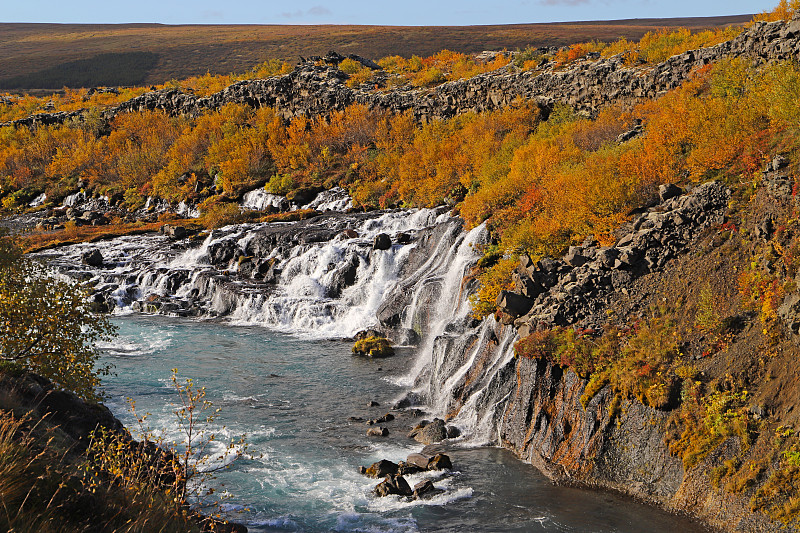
500,352,794,533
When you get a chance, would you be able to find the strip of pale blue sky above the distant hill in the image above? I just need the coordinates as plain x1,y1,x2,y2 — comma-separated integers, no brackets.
0,0,778,26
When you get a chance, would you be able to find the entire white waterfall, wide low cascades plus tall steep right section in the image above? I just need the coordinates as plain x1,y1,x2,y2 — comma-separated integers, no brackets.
38,206,515,444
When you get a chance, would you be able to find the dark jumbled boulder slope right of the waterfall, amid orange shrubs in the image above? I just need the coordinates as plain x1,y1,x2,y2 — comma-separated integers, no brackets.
497,182,729,337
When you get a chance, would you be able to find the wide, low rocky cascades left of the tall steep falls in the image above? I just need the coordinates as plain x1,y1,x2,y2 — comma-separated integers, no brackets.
39,209,456,337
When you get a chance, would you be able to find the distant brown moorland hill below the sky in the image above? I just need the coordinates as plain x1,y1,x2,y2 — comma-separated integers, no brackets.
0,15,752,90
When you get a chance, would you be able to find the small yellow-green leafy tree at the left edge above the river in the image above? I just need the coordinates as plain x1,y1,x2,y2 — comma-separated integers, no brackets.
0,235,115,400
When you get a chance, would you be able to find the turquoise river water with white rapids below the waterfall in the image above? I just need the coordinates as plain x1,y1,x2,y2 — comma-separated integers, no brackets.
97,315,705,533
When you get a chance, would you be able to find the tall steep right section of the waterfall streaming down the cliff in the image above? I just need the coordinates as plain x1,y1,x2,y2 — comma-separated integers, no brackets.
388,216,516,445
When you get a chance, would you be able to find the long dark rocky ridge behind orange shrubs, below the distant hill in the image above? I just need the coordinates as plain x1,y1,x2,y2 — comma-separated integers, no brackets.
6,15,800,126
